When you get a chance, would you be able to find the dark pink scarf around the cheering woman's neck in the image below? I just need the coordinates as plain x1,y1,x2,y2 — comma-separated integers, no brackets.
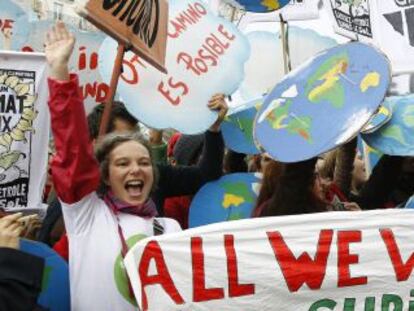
103,191,158,218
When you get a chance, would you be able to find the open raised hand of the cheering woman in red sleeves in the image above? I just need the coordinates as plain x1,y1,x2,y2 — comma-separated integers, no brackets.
45,21,75,81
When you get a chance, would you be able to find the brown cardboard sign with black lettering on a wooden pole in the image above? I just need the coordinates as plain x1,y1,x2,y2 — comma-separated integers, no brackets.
77,0,168,72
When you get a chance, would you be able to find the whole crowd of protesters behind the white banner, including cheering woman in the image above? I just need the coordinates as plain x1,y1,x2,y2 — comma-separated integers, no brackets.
0,22,414,310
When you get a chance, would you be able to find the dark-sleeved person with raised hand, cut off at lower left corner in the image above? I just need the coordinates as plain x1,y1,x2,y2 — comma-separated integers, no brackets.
0,213,44,311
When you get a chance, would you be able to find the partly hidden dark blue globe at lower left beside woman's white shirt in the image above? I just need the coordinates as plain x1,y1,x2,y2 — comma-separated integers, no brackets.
20,239,70,311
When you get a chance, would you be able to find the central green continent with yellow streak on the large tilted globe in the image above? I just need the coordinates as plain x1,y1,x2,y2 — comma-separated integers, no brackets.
305,53,349,108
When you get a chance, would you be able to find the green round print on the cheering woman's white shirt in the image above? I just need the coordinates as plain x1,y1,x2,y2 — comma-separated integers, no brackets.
114,234,147,307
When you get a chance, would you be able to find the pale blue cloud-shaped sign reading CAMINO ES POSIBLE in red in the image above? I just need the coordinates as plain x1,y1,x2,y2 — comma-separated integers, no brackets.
99,0,249,134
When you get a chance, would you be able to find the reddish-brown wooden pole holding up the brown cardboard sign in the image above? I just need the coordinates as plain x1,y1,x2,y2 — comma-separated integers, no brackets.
99,43,125,137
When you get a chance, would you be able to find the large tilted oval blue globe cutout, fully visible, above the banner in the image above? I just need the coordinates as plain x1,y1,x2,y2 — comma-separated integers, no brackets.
254,42,391,162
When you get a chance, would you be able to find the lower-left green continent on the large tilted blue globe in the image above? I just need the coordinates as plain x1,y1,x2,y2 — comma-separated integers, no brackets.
266,99,313,143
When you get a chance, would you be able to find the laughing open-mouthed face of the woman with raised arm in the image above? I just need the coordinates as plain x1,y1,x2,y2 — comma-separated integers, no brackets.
108,140,154,205
